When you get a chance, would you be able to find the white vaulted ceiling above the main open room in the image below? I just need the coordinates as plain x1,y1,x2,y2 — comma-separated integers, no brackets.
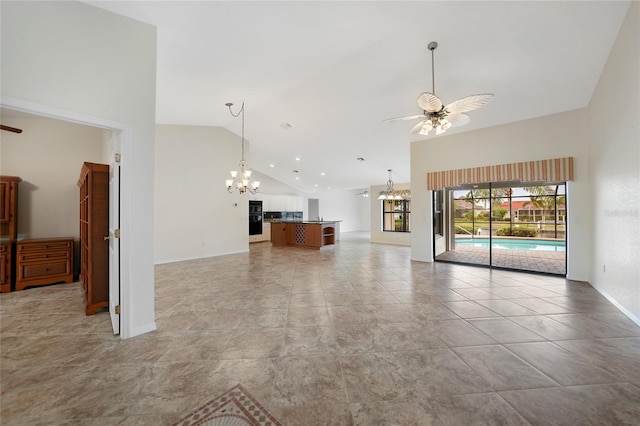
86,1,629,192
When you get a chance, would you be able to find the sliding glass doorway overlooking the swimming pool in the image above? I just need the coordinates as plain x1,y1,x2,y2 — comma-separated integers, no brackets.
433,182,567,276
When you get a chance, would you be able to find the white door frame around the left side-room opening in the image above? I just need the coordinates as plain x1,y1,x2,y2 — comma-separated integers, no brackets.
0,96,133,339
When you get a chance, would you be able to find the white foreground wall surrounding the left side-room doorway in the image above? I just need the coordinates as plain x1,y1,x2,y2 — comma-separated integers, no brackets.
0,1,156,337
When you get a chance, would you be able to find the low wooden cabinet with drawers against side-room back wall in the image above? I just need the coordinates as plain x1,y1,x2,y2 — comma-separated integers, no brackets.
16,238,73,290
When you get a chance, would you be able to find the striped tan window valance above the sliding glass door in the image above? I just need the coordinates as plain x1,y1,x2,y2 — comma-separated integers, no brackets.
427,157,573,190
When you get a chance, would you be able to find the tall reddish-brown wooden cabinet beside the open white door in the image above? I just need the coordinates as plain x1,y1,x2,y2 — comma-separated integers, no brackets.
78,163,109,315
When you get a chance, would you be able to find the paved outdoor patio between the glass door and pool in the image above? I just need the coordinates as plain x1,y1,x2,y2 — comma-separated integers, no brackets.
436,246,566,276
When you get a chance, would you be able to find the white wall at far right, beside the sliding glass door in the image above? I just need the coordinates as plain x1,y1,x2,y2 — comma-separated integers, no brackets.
588,2,640,325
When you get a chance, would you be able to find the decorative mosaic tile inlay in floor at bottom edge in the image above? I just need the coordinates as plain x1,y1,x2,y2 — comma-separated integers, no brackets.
174,384,280,426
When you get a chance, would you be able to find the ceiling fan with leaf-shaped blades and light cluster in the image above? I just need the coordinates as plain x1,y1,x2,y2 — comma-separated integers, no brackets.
384,41,494,135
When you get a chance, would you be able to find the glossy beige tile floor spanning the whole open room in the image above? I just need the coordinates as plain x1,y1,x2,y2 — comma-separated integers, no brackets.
0,233,640,425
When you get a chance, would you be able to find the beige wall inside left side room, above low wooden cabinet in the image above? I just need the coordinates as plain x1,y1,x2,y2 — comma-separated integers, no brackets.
0,115,111,241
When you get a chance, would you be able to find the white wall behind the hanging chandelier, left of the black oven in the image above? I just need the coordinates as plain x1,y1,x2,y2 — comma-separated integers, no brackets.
154,125,250,263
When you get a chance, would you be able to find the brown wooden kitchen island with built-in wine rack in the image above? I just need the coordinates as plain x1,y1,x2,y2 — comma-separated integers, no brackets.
271,221,339,250
